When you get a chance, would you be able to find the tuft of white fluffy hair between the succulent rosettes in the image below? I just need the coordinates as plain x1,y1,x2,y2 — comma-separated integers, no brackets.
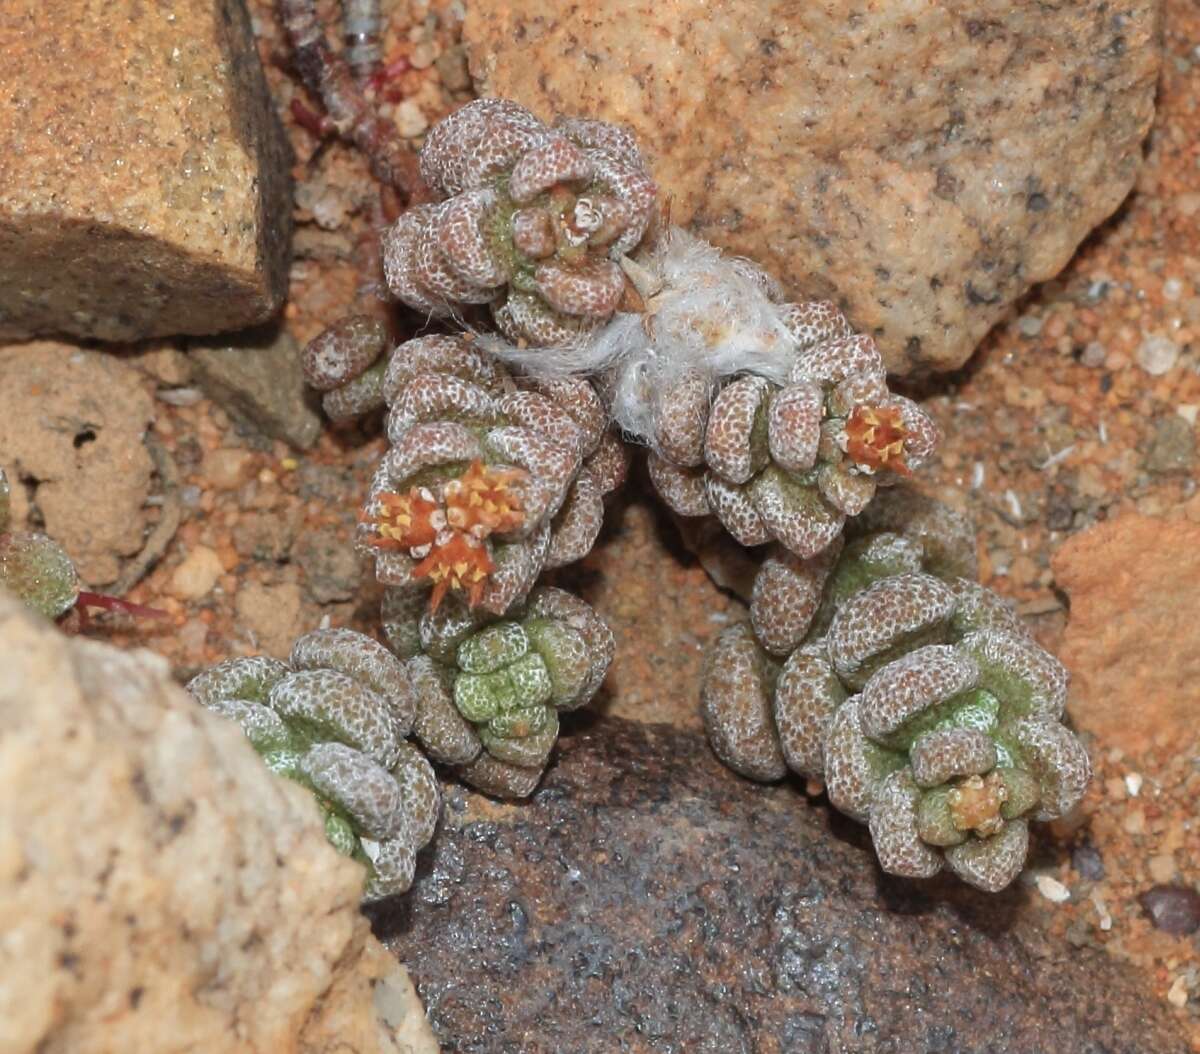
476,227,797,443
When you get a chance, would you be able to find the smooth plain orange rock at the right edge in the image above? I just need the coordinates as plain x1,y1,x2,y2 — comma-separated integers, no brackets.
1052,514,1200,754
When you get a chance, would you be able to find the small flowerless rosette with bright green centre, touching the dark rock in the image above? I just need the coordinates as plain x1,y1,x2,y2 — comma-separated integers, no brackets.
383,587,614,798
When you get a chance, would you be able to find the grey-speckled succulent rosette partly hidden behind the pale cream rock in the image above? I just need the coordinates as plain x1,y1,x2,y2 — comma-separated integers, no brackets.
187,629,442,900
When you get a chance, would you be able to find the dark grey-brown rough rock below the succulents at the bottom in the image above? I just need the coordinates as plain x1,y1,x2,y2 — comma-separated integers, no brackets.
376,719,1186,1054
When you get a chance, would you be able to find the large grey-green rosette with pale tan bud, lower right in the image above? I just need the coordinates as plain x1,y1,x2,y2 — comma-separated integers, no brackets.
702,492,1091,891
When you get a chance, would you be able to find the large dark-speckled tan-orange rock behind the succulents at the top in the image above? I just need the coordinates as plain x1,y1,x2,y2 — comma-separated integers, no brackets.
464,0,1160,372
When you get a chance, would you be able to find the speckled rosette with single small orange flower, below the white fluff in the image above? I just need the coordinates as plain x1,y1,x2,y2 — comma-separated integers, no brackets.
650,301,938,558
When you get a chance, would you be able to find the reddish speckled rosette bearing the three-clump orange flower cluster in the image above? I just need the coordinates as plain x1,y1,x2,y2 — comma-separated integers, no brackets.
360,336,625,615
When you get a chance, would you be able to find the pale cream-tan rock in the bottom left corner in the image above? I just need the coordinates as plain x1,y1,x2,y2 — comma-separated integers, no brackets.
0,593,437,1054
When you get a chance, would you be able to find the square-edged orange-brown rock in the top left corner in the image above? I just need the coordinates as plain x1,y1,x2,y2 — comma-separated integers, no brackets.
0,0,290,340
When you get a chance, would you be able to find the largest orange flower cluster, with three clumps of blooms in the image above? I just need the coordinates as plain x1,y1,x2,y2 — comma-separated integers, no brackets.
372,461,526,611
